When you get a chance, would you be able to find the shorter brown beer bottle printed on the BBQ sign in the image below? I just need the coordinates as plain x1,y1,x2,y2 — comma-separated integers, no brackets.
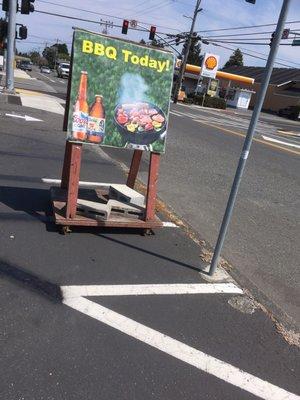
87,95,105,143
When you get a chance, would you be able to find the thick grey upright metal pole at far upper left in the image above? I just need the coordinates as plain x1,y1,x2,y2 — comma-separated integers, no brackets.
6,0,17,93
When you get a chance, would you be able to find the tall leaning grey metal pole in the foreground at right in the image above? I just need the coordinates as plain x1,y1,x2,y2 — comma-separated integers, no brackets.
209,0,291,276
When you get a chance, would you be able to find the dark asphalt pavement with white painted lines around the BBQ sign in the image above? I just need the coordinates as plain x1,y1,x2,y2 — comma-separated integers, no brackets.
0,94,300,400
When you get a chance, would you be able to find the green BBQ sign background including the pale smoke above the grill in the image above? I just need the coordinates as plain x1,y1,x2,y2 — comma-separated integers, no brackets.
68,30,174,153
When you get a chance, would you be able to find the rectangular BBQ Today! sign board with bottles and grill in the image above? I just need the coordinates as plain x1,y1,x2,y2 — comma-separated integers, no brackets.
66,29,174,153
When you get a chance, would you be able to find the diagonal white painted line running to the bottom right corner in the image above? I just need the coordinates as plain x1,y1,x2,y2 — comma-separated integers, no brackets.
63,297,300,400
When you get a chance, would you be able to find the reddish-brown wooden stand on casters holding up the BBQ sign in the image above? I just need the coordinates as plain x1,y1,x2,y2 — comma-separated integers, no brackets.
50,141,163,231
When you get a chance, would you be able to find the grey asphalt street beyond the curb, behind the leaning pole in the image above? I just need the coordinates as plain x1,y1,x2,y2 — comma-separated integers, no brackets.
10,70,300,327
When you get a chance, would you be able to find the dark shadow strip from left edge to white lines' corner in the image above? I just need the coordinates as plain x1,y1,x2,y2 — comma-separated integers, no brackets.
0,260,63,303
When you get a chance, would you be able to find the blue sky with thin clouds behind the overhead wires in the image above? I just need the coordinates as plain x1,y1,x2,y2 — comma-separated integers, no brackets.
0,0,300,68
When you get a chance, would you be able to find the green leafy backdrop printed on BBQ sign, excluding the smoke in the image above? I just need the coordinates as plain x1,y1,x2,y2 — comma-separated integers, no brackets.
68,30,174,152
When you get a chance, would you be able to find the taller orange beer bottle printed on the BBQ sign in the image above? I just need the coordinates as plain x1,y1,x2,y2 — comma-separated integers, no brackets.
72,71,89,141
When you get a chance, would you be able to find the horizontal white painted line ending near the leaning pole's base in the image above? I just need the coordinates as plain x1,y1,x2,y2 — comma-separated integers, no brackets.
61,282,243,298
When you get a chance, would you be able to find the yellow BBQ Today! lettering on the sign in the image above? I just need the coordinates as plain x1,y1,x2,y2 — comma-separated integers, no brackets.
82,40,170,72
